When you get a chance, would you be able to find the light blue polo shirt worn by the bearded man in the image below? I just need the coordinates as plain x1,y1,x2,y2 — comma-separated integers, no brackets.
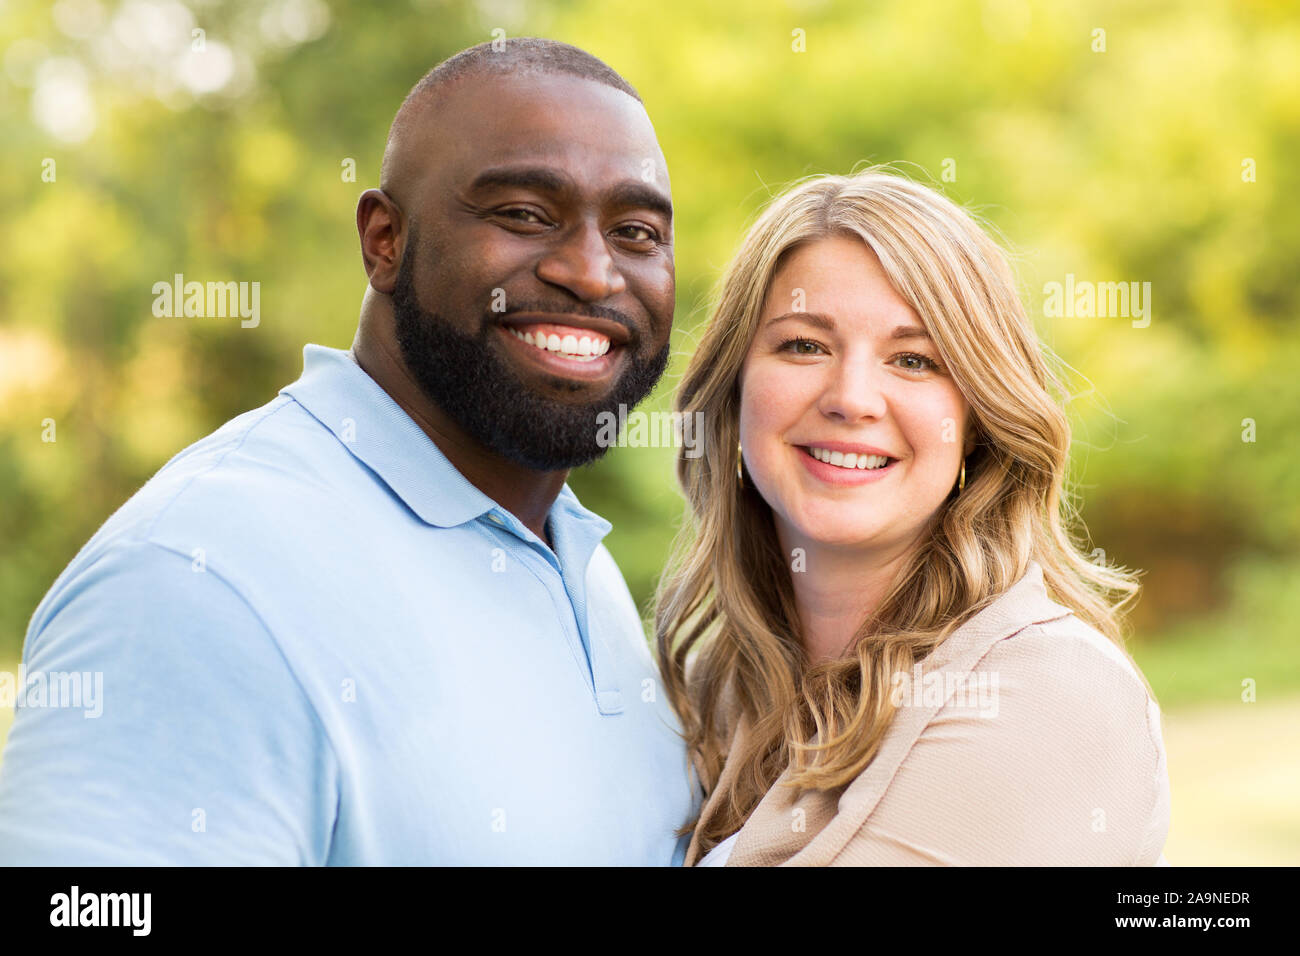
0,345,697,866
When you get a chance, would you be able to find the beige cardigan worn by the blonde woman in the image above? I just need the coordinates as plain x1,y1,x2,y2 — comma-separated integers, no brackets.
685,562,1169,866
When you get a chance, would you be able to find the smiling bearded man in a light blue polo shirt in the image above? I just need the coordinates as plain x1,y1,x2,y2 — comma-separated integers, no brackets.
0,39,692,865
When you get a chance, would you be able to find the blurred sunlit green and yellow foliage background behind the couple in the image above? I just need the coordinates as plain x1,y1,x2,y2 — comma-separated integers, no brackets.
0,0,1300,865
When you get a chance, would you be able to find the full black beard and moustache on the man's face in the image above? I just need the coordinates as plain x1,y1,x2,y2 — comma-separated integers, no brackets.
393,234,668,471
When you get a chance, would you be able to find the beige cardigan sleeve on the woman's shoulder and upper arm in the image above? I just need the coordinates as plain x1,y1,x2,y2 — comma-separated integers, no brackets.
833,622,1169,866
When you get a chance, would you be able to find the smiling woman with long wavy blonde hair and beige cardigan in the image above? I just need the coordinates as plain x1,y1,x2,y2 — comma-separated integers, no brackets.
655,169,1169,865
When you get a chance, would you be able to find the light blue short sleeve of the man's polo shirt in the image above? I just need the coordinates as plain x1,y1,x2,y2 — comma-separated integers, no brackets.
0,542,338,865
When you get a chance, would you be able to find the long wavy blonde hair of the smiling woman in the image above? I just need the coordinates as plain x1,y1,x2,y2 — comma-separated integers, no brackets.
655,168,1139,851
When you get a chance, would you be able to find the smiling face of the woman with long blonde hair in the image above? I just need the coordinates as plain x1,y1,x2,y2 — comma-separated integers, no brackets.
740,237,969,558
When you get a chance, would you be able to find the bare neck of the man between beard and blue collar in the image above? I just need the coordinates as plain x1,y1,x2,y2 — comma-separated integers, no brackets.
352,316,568,546
